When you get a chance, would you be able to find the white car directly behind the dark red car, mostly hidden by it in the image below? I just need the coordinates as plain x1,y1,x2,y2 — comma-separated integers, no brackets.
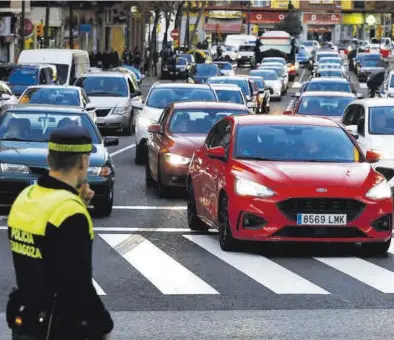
133,83,218,164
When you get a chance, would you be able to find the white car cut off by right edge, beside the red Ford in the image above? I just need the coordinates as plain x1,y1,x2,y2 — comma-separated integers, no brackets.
342,98,394,191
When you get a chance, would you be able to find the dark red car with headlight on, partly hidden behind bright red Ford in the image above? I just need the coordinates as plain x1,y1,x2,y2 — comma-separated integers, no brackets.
146,102,250,197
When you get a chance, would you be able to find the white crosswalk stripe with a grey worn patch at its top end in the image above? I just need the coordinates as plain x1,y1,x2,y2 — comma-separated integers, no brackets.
100,234,219,295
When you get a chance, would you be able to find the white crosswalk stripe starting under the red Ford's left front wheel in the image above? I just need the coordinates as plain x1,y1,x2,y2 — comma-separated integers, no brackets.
183,235,330,295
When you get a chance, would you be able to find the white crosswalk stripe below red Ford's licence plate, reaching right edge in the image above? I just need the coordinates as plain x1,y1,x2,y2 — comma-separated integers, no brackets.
314,257,394,293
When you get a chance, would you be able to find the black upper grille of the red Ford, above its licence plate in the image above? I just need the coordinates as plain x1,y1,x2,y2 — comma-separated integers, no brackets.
277,198,365,222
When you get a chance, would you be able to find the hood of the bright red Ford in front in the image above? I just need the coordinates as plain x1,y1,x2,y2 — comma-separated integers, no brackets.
235,160,372,188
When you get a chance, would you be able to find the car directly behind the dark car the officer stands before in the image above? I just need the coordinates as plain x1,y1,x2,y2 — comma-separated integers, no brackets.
19,85,97,123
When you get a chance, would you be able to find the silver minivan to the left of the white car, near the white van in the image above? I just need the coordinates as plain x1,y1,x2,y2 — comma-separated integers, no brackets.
75,72,142,135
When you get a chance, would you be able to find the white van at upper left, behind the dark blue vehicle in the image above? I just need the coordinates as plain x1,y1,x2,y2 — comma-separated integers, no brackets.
18,49,90,85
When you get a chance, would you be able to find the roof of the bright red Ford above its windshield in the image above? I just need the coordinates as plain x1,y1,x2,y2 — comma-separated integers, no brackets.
233,115,339,127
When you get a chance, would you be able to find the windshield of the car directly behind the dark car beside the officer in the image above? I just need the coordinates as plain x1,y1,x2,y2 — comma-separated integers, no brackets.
19,87,81,106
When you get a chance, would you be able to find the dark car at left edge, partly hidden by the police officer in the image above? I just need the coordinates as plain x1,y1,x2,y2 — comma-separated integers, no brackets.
0,105,119,216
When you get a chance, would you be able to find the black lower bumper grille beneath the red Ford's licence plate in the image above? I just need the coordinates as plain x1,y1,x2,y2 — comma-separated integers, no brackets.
272,226,368,238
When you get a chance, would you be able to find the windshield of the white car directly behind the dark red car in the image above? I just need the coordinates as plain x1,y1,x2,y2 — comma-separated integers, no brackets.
146,87,216,109
